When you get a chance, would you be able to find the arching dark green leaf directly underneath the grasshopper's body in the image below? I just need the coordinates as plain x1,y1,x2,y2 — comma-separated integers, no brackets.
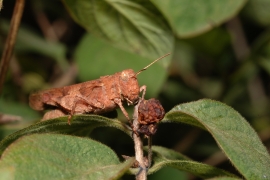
0,115,131,154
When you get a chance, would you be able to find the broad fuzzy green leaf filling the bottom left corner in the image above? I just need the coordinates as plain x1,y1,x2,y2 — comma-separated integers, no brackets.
0,134,134,179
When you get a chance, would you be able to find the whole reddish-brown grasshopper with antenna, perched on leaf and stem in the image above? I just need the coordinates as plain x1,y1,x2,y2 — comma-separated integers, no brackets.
29,53,170,124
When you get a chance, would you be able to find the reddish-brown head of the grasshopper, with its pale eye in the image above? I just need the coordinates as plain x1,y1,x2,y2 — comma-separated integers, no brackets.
119,69,140,105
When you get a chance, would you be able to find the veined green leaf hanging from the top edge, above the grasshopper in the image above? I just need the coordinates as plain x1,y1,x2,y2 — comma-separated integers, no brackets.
63,0,174,59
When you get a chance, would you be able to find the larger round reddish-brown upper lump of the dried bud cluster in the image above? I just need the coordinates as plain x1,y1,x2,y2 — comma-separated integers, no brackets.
138,99,165,125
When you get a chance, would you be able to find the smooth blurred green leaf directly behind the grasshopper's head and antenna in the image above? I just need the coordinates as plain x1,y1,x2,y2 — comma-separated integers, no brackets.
75,34,172,97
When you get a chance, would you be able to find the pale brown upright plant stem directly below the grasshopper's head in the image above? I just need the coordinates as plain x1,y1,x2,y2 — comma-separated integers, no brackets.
133,99,147,180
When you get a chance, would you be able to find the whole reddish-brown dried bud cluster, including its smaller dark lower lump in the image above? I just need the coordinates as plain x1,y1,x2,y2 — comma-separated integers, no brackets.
138,99,165,136
